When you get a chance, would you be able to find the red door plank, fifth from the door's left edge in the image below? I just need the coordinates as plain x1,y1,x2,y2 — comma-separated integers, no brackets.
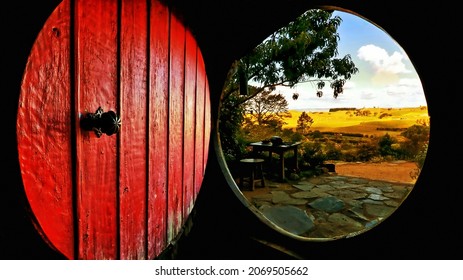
167,13,185,242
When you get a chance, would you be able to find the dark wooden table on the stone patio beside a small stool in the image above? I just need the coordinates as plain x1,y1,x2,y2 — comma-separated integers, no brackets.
248,141,301,180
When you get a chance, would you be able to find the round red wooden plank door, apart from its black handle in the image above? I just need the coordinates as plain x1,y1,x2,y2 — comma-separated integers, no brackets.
17,0,210,259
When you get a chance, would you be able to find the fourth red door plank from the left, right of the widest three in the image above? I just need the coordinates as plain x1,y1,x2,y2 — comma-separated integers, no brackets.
148,0,169,259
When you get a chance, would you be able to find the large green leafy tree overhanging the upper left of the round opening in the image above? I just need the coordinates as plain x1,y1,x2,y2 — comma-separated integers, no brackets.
219,9,358,161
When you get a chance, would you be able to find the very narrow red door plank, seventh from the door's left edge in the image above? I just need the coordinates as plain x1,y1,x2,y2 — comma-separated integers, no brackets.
195,50,206,197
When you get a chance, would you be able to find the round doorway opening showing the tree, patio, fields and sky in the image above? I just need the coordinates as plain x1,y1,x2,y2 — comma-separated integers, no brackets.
217,8,430,241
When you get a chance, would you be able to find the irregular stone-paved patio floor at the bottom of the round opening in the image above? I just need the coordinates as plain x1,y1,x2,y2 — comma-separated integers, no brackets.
245,173,413,238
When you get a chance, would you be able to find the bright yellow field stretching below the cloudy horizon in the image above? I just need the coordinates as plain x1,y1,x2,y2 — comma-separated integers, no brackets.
284,106,429,136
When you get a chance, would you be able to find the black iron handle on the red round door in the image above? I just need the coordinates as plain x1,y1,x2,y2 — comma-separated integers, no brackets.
80,107,122,138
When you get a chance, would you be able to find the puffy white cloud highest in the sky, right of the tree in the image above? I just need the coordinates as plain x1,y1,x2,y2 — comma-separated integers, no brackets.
357,44,410,74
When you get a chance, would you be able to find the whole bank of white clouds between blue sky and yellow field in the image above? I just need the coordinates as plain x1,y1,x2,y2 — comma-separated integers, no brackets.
254,44,426,110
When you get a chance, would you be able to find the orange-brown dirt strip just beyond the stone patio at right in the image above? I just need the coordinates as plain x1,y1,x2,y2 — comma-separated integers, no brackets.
335,161,418,183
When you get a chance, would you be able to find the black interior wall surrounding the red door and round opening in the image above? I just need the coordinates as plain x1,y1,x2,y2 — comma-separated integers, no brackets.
0,0,463,259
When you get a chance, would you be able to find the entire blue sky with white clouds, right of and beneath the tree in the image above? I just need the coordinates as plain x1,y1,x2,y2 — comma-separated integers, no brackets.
277,11,427,110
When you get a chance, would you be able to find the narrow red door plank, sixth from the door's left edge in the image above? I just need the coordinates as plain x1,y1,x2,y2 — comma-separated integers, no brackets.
183,30,197,217
